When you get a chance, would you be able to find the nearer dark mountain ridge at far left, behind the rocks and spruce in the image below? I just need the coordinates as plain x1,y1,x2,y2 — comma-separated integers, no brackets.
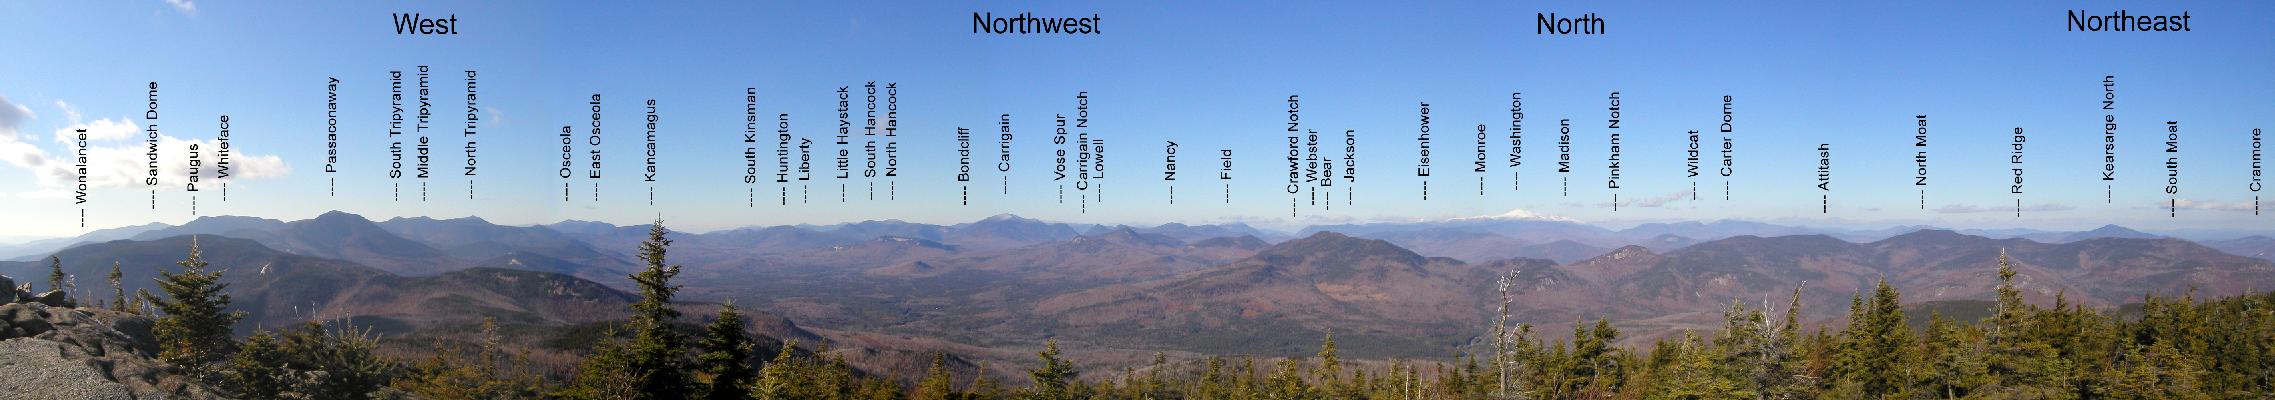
0,234,632,334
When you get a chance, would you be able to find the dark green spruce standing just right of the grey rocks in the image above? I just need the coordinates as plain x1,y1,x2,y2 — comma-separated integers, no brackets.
143,236,246,370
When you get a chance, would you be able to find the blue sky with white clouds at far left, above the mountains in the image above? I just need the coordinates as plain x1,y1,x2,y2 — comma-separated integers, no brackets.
0,0,2275,236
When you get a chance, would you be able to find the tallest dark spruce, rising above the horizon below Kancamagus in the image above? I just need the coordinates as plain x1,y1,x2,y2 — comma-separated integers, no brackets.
626,218,689,398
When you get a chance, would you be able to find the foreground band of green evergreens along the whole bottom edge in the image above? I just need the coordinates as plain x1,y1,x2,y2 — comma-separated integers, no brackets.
0,223,2275,400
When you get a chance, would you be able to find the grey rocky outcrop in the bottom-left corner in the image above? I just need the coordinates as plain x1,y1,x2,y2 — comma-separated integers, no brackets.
0,282,218,400
